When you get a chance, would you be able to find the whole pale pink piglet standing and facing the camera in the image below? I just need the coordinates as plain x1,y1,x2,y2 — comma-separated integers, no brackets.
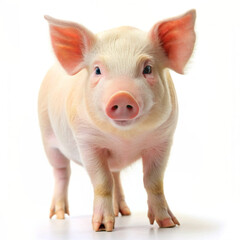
39,10,195,231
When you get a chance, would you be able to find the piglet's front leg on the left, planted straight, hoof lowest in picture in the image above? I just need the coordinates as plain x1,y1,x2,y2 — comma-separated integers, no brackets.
82,150,115,232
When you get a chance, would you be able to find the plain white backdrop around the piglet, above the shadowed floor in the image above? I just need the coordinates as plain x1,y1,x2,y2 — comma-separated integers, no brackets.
0,0,240,239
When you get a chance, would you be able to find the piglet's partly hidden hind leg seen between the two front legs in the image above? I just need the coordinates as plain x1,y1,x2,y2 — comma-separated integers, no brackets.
112,172,131,216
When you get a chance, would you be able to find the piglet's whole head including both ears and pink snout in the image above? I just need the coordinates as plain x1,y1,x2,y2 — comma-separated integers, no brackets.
46,10,195,136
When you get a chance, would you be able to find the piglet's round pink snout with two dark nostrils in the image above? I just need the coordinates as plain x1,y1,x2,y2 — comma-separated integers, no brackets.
106,91,139,120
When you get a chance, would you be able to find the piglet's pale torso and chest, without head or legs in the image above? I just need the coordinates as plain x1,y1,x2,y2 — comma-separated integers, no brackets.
39,64,177,171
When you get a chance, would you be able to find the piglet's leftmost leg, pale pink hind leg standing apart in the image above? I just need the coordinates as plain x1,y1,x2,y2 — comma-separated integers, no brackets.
46,148,71,219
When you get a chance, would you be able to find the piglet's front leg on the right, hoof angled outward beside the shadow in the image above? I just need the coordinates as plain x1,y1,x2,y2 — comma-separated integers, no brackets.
142,143,179,228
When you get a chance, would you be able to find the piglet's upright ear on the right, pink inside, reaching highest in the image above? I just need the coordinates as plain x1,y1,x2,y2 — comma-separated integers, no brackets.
150,10,196,74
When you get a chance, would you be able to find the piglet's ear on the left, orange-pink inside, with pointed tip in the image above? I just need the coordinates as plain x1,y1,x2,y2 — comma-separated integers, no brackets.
45,16,95,75
